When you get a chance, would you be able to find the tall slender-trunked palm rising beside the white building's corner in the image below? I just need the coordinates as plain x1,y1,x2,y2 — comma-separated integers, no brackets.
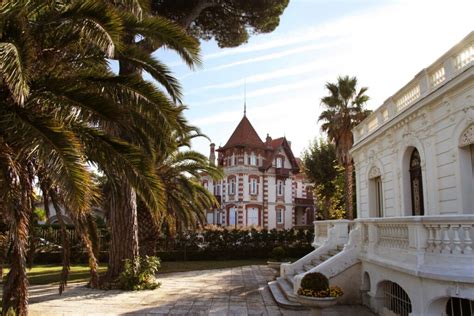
319,76,371,219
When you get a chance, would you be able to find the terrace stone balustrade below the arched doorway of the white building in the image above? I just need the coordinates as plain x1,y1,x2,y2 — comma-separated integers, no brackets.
355,215,474,279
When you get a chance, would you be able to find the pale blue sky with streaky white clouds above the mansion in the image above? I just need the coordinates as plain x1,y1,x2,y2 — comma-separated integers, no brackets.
150,0,474,156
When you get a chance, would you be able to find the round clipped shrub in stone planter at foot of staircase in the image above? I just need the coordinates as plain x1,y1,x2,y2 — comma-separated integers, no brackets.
296,272,344,316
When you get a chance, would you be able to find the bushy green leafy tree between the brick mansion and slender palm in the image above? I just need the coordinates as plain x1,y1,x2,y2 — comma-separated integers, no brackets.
303,139,342,219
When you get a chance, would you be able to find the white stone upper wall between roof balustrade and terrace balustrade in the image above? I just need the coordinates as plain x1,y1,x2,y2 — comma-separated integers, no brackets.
353,80,474,218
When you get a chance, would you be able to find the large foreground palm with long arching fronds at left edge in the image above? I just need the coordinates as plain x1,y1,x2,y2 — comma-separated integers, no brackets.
0,0,197,315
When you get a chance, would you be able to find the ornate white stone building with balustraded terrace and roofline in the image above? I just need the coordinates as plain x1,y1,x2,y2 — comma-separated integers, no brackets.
282,33,474,316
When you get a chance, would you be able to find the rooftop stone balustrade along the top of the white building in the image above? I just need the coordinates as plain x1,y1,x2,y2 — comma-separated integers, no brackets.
353,32,474,145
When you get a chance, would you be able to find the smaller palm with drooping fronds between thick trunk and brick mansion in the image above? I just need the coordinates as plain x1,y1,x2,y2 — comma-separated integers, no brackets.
138,127,222,256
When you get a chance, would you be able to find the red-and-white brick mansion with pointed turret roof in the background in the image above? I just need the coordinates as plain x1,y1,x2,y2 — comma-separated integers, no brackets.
201,112,315,229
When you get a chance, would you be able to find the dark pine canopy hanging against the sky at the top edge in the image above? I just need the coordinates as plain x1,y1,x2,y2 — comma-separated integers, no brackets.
151,0,289,47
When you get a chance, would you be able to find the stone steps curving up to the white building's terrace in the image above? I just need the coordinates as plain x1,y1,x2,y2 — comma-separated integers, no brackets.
268,245,343,310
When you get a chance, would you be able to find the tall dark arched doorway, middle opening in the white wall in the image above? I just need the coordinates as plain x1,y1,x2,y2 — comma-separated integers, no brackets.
410,148,425,216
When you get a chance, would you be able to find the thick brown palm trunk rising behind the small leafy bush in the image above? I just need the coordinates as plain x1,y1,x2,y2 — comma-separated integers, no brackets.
106,182,139,286
